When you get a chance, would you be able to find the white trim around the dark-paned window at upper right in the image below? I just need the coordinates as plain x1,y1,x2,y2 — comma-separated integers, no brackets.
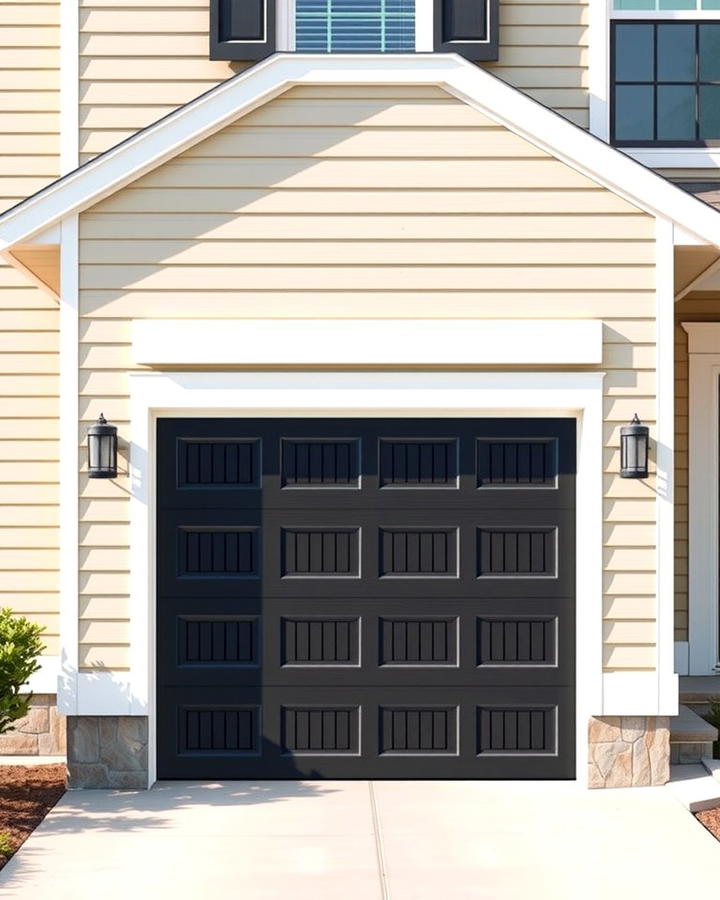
588,0,720,169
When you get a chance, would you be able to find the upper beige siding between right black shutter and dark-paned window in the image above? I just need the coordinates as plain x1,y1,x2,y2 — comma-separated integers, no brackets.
483,0,590,128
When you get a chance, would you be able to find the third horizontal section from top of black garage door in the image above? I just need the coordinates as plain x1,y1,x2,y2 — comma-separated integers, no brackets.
159,600,572,687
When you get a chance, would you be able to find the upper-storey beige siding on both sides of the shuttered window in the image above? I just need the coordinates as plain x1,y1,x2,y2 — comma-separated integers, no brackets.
80,0,589,162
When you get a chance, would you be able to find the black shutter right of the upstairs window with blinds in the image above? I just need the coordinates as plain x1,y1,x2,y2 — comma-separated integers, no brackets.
435,0,499,61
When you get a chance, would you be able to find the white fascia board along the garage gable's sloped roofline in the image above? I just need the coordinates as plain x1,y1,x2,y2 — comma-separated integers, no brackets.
0,53,720,250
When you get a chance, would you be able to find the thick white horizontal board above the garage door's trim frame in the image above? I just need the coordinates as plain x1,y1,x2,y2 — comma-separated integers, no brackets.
132,319,602,367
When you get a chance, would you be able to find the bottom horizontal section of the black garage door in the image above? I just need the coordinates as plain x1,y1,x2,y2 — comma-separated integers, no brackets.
158,687,574,778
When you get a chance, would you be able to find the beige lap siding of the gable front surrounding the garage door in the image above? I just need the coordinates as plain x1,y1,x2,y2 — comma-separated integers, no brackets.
78,87,656,669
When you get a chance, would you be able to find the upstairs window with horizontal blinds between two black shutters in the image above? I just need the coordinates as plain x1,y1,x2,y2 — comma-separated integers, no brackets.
295,0,415,53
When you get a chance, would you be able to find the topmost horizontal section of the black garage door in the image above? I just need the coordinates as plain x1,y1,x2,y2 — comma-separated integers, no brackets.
158,419,575,509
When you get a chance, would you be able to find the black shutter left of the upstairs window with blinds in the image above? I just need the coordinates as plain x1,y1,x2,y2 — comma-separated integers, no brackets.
210,0,275,60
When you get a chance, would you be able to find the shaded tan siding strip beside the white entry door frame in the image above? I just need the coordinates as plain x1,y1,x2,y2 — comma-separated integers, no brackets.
675,291,720,641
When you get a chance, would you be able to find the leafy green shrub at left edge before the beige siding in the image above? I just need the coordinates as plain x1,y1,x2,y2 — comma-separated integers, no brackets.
0,608,45,734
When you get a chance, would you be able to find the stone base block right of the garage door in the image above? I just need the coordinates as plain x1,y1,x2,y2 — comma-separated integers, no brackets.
588,716,670,788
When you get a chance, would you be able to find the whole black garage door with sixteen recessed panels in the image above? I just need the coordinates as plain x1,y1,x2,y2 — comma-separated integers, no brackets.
157,419,575,778
